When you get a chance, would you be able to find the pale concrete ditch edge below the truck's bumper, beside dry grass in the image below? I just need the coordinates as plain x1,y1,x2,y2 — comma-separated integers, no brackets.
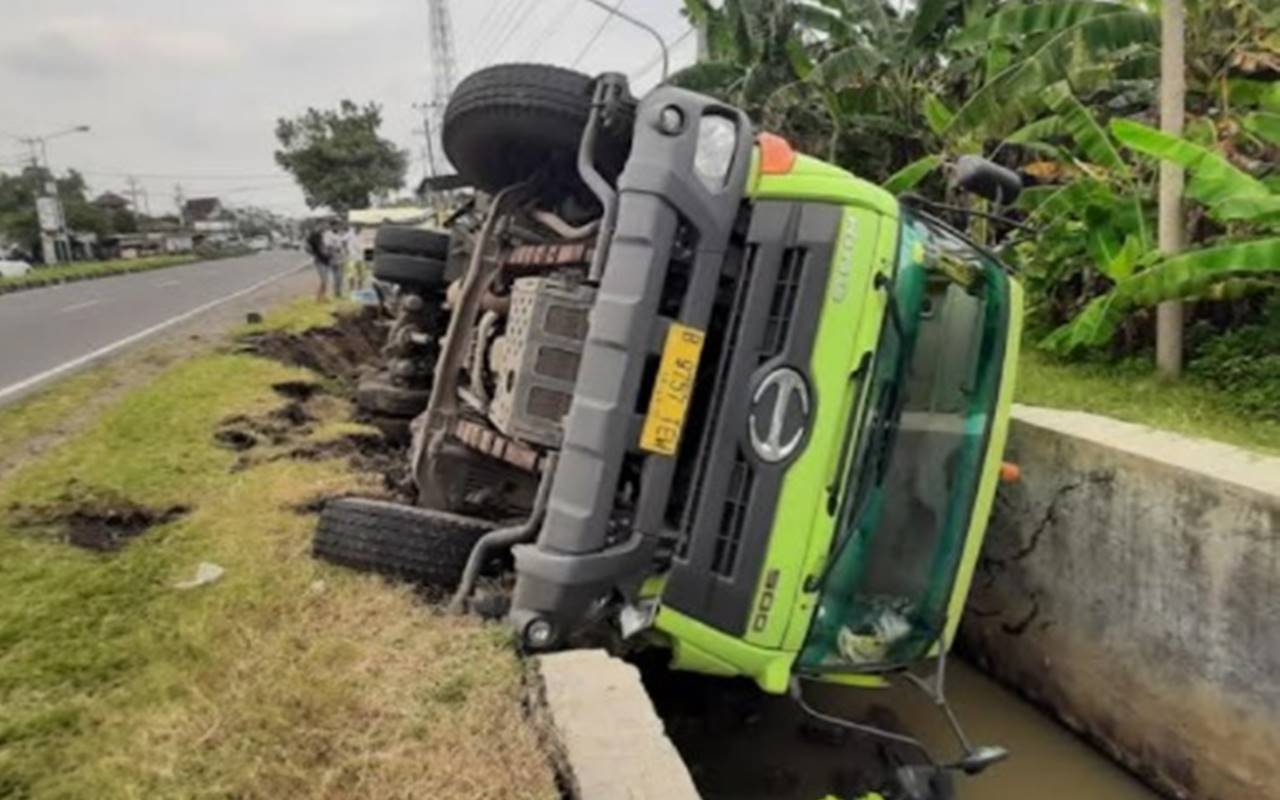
534,650,699,800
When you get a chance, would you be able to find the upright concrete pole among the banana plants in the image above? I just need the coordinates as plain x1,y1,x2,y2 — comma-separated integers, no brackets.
1156,0,1187,378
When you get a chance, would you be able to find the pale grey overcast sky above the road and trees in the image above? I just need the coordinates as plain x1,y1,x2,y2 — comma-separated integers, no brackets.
0,0,694,214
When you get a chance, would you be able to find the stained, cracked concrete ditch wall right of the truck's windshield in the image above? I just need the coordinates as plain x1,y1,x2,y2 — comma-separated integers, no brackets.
960,407,1280,800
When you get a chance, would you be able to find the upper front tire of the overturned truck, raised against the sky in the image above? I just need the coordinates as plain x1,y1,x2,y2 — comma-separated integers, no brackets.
442,64,635,192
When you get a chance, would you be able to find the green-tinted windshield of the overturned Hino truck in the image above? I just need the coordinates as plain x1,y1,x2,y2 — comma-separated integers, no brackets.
800,211,1009,672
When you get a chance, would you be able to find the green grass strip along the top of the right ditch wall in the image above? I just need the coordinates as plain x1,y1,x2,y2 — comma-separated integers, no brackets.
1018,349,1280,454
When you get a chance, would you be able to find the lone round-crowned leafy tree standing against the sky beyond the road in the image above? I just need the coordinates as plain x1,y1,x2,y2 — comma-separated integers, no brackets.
275,100,408,210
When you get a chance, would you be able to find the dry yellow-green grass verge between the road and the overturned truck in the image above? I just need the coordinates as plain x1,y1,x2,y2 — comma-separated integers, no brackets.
0,303,557,800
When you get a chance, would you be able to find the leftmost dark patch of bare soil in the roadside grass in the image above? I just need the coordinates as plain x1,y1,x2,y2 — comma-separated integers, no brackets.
12,483,191,552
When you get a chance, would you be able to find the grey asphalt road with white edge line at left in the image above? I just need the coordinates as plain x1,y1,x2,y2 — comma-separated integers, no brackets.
0,251,305,403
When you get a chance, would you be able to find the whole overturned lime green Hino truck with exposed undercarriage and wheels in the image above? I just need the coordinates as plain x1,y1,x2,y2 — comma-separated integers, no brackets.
315,65,1023,796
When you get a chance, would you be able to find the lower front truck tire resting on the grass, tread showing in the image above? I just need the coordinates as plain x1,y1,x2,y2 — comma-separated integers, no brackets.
311,498,494,589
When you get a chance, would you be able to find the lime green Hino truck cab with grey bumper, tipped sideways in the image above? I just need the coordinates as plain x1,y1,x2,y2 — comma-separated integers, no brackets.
511,88,1021,692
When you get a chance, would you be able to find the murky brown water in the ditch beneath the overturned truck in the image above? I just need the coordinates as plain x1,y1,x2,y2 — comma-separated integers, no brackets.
645,660,1157,800
